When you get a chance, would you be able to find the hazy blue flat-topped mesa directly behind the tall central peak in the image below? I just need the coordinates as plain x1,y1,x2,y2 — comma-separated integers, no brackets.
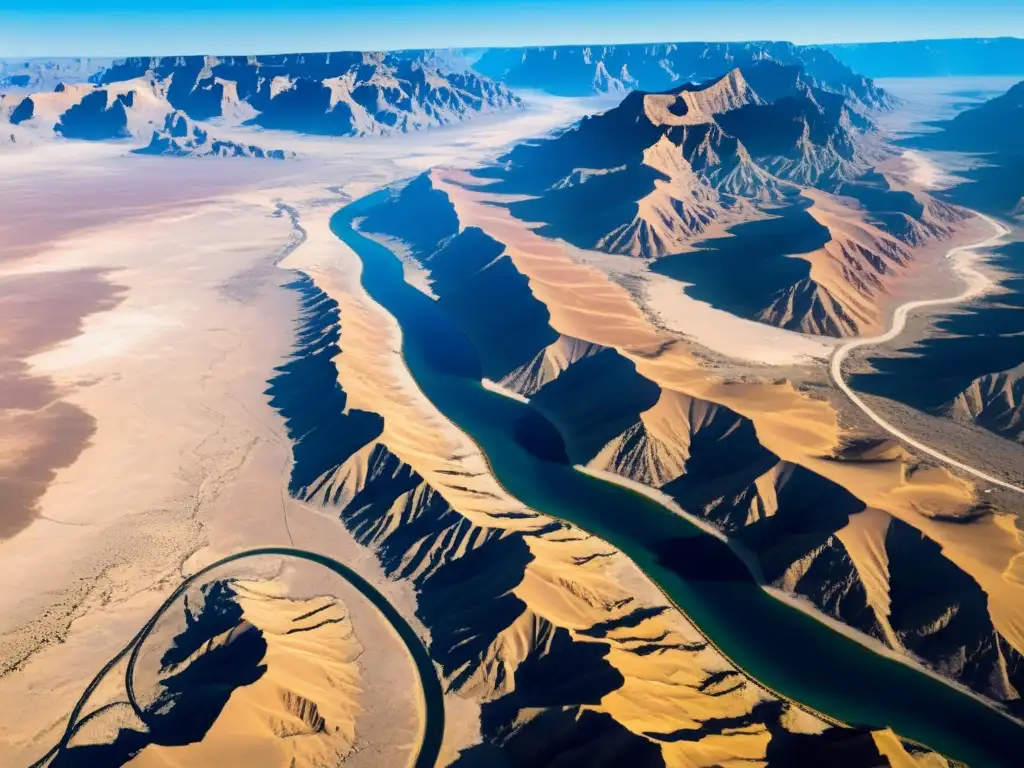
475,42,892,108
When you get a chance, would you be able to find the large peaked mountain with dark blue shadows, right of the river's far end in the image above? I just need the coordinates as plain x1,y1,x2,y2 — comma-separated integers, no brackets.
477,58,964,336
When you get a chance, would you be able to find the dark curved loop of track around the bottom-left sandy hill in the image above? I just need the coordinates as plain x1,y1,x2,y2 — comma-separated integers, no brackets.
31,547,444,768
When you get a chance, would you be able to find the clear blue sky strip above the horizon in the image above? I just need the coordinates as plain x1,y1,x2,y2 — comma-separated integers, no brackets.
0,0,1024,57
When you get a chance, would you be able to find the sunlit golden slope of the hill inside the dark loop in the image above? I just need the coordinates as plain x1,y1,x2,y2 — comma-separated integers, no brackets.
128,582,361,768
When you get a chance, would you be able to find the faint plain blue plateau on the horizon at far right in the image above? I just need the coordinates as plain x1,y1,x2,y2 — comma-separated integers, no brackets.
821,37,1024,78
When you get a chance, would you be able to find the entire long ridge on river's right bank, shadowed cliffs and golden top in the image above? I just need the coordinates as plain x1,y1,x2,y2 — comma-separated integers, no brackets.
350,160,1024,729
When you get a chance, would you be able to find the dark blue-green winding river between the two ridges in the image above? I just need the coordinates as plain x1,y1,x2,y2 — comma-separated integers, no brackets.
331,193,1024,768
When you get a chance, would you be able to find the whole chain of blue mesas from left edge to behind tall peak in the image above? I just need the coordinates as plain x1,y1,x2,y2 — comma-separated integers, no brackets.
0,42,892,152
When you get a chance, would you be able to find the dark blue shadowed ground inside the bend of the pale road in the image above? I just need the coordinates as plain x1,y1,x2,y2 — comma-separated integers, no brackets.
849,243,1024,415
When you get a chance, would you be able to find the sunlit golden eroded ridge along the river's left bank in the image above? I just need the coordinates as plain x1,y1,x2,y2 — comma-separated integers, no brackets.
280,210,856,767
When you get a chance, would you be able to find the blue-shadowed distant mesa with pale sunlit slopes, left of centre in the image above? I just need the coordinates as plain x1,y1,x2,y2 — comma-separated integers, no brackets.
0,52,521,150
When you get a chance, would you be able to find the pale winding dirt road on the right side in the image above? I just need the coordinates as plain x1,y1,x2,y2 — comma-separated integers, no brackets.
828,212,1024,494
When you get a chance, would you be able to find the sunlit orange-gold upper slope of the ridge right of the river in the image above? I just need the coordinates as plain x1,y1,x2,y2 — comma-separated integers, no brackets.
432,166,1024,671
